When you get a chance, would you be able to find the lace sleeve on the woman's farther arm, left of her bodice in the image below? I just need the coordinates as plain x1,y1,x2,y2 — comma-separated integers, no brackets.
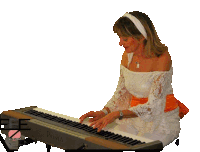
105,66,132,112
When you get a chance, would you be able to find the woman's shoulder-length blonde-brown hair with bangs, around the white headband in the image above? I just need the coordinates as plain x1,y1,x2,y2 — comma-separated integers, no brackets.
113,11,168,58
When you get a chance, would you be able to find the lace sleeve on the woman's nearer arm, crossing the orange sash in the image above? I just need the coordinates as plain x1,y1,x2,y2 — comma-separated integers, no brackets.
129,72,171,122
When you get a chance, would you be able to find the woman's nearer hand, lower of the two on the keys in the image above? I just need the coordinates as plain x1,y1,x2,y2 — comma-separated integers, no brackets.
89,112,117,132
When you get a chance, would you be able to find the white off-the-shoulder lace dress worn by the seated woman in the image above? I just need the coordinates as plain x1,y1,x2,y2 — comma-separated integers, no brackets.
105,53,181,147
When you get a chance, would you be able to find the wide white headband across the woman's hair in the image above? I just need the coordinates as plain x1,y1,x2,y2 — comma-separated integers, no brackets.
123,13,147,39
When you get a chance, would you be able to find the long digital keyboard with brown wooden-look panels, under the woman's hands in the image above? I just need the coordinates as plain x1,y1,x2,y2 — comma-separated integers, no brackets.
1,106,163,150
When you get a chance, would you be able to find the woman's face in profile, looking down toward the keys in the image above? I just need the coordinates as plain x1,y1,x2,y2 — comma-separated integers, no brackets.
119,37,145,54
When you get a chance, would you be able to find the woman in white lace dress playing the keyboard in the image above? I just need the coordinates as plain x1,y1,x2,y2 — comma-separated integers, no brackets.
80,11,189,147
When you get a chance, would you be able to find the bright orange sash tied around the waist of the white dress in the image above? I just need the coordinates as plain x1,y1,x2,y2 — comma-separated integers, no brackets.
131,94,189,119
